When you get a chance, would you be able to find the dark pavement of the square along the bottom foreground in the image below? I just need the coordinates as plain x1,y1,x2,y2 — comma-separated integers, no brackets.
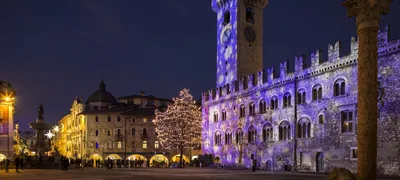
0,168,394,180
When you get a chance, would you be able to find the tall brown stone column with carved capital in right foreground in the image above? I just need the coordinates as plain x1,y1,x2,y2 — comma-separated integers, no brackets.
343,0,391,180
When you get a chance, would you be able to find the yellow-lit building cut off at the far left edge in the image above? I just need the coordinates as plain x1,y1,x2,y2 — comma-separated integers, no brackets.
0,80,15,161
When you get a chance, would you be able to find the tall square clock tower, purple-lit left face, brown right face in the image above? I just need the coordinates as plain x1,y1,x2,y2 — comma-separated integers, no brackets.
211,0,268,87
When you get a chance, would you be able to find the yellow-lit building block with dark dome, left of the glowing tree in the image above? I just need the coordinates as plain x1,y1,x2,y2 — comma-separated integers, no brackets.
54,82,200,166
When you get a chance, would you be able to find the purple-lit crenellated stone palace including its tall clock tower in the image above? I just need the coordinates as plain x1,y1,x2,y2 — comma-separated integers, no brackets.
202,0,400,175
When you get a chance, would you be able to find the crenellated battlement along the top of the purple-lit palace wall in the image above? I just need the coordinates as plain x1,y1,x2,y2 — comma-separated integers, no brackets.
202,26,400,102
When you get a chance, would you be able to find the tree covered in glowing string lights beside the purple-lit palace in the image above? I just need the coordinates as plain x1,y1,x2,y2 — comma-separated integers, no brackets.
154,89,201,167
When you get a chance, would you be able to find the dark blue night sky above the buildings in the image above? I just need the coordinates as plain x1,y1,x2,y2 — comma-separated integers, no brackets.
0,0,400,130
